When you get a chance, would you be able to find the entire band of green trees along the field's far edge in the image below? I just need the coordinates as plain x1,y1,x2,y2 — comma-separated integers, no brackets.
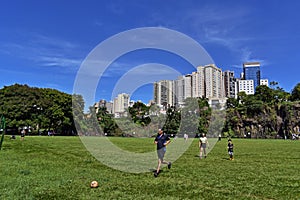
0,82,300,138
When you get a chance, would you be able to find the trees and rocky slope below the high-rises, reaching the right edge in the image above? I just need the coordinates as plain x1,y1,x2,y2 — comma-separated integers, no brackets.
91,81,300,138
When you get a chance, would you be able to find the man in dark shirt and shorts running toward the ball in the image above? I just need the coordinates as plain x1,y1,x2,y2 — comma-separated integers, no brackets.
154,129,171,177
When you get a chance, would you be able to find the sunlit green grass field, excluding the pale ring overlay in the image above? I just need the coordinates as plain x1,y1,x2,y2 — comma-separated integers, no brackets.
0,136,300,200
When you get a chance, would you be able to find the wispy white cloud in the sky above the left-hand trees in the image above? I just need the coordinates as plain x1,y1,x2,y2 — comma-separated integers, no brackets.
2,33,82,67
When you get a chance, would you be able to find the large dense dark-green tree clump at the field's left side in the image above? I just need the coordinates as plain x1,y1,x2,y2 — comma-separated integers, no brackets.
0,84,81,135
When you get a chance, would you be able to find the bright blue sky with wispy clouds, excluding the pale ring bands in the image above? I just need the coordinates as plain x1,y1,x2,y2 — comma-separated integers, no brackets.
0,0,300,107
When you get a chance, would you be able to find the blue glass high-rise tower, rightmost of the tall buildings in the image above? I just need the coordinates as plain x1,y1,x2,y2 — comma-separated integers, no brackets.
243,62,260,91
